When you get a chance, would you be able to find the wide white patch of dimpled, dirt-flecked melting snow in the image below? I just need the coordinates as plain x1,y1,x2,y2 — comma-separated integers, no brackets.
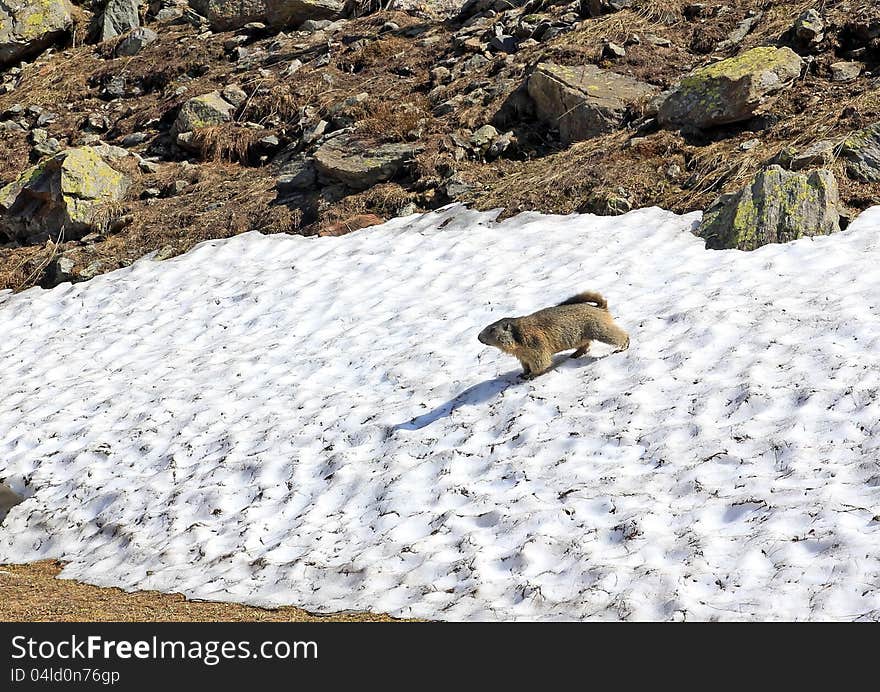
0,207,880,620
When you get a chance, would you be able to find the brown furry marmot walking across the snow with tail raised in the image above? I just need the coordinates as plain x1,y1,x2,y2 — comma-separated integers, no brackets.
477,291,629,380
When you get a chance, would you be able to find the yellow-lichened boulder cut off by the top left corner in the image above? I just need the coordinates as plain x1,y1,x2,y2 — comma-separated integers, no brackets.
0,0,73,65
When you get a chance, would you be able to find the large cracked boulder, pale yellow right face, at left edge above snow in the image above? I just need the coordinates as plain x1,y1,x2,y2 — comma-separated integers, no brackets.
0,147,129,243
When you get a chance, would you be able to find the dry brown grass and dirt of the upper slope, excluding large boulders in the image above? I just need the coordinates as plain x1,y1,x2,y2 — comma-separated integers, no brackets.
0,0,880,290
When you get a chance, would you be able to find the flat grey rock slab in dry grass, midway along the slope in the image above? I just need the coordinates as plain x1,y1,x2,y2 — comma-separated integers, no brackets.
315,135,419,190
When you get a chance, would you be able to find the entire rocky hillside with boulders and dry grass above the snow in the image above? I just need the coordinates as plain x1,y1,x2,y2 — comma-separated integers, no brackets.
0,0,880,290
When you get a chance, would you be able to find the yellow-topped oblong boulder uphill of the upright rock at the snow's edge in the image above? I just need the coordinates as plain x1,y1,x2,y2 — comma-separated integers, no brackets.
657,46,803,130
